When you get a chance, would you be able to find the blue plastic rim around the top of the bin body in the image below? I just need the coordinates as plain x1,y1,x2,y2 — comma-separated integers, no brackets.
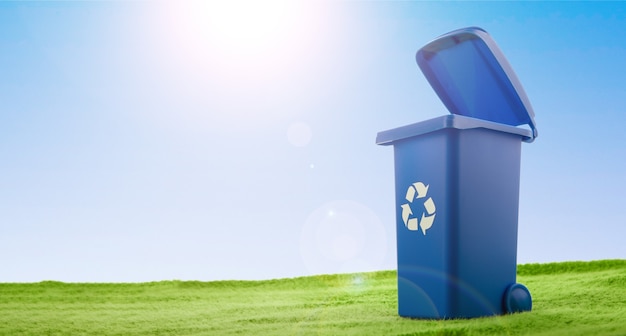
376,114,533,146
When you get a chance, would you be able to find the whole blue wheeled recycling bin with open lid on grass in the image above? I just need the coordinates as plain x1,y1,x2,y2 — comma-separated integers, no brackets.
376,27,537,319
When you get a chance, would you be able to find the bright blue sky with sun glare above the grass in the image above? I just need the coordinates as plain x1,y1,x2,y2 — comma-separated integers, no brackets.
0,1,626,282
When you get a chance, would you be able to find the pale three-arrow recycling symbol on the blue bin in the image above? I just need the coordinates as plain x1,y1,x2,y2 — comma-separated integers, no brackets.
400,182,436,235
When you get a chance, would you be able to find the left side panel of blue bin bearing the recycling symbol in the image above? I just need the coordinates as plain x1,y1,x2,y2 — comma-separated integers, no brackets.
394,130,454,318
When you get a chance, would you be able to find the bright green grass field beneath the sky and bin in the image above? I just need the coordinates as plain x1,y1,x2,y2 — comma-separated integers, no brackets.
0,260,626,336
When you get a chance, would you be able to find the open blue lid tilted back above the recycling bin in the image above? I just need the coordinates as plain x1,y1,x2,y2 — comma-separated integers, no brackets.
415,27,537,142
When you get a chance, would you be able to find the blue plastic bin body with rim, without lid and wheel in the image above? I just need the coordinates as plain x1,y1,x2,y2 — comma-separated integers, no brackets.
377,115,531,319
